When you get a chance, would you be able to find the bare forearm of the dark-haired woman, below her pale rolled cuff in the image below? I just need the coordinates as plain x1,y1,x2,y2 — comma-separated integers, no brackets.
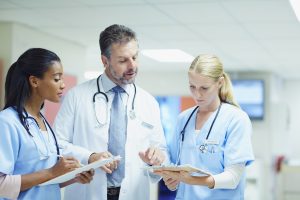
21,169,55,191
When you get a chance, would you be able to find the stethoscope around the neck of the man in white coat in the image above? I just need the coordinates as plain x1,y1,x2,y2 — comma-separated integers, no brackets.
93,75,136,126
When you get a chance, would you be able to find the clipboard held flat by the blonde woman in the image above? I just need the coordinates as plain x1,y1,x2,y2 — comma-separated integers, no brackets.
146,164,211,176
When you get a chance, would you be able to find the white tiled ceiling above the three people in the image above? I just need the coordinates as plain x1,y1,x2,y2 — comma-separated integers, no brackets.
0,0,300,79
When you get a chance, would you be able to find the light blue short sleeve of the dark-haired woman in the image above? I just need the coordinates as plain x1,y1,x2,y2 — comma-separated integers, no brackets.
0,116,19,174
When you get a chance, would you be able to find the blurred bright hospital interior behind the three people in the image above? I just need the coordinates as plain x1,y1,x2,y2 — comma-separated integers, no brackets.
0,0,300,200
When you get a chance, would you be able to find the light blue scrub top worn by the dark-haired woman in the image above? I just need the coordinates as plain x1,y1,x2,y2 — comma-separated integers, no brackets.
0,108,61,200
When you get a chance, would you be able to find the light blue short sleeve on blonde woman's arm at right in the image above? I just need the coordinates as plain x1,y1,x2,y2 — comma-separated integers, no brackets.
224,111,254,167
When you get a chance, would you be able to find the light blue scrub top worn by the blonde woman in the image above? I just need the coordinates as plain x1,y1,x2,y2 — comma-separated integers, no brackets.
168,103,254,200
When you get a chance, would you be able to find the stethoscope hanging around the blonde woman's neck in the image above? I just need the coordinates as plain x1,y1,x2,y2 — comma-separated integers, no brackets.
176,103,222,165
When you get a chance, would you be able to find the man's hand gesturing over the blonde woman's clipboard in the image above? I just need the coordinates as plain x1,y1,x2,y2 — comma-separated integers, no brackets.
139,147,165,165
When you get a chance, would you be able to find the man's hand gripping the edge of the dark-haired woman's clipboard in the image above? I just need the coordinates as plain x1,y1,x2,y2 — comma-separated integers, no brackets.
88,151,119,174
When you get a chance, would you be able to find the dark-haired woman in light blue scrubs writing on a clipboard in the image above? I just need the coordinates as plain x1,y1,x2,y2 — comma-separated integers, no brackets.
0,48,94,200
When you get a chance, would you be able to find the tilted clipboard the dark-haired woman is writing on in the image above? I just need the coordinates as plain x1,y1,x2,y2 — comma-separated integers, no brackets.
39,156,121,186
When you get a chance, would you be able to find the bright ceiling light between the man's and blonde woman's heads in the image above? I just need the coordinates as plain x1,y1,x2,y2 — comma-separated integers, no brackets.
141,49,194,62
